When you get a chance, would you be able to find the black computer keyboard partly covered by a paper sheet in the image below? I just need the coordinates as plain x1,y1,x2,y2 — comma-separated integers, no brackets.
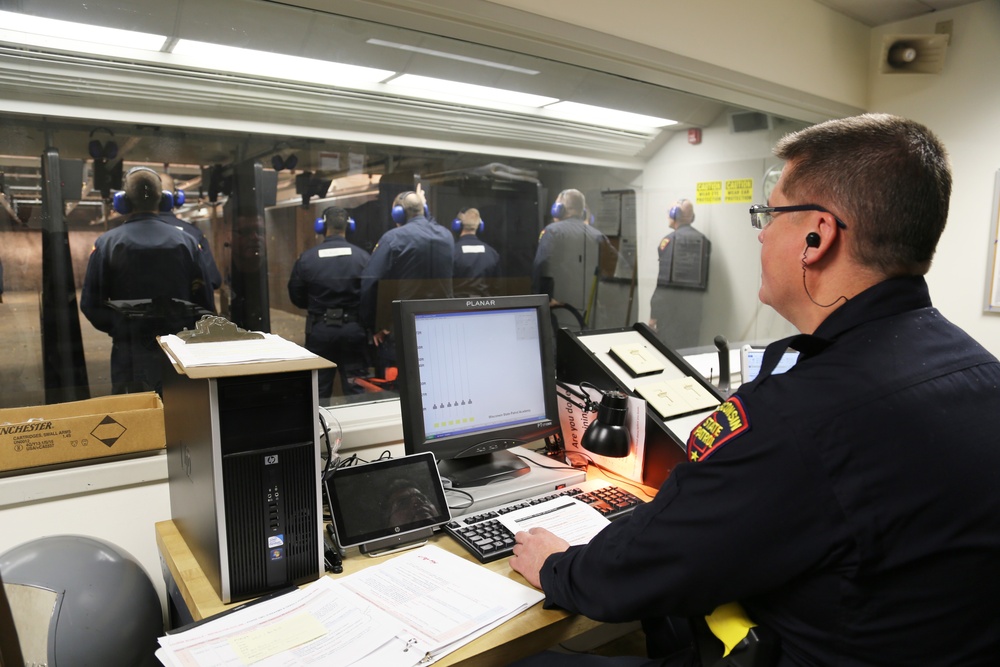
444,479,643,563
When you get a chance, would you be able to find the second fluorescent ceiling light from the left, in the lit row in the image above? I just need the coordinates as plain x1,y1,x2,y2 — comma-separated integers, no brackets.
171,39,395,86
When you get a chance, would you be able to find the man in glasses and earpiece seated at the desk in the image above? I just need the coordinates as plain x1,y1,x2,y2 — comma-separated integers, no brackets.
510,114,1000,667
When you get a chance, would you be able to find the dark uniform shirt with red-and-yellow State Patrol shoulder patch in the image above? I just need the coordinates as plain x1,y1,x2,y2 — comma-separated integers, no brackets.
541,277,1000,667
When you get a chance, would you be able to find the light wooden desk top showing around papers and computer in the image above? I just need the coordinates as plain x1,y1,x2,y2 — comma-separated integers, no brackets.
156,468,648,667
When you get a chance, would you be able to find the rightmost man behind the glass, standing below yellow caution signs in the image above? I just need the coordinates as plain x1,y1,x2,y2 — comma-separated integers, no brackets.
649,199,712,350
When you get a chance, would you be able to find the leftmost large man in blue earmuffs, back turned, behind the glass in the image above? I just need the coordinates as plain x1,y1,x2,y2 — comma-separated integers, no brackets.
80,167,215,394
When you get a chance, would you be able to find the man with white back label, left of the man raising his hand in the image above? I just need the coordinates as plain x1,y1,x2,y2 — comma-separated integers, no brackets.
288,206,369,398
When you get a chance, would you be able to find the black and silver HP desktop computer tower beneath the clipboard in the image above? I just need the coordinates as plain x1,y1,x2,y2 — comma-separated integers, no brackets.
163,364,323,603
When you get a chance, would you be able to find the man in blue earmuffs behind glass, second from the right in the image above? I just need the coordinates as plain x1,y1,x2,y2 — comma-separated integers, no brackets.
531,189,610,324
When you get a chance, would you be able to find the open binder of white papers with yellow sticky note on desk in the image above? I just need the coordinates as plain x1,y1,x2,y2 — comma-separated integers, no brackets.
157,546,544,667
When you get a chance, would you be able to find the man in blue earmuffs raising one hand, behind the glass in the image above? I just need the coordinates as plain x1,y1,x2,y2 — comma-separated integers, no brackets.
361,184,455,373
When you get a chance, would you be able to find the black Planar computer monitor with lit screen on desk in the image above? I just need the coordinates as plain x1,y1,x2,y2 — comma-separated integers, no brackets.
393,295,560,487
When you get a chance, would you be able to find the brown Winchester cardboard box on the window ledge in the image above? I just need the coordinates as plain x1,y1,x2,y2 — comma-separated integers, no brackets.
0,392,166,471
